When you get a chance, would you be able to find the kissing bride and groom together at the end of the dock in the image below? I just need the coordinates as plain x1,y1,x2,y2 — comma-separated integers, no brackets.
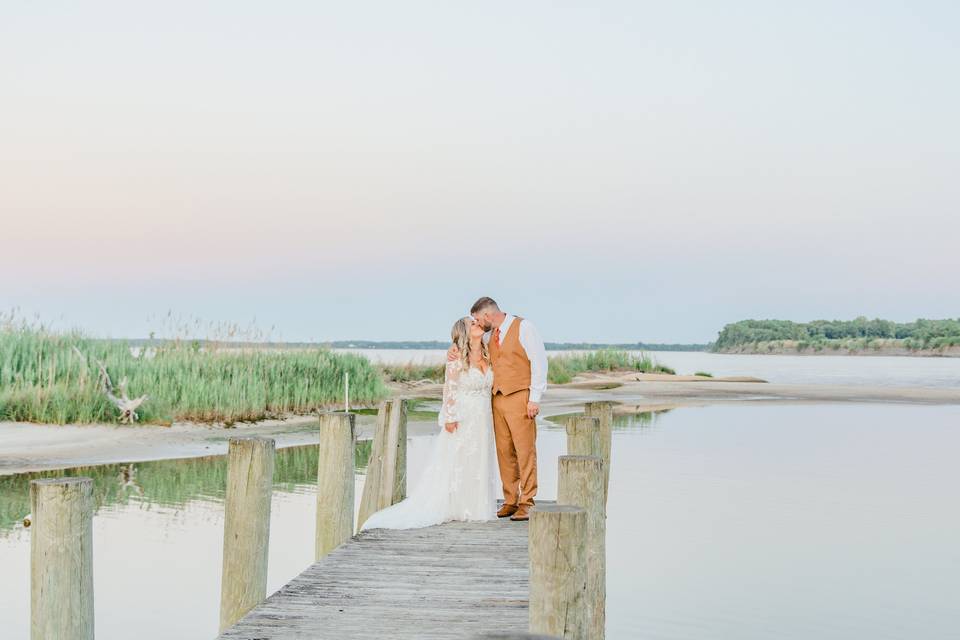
363,297,547,529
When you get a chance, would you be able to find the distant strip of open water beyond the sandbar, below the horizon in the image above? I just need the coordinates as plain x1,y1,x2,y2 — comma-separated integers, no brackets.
343,349,960,387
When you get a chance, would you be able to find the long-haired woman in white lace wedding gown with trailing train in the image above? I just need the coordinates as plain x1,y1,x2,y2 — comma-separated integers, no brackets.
361,317,499,529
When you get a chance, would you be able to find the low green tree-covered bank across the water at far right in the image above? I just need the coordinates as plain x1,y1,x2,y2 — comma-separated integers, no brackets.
714,316,960,351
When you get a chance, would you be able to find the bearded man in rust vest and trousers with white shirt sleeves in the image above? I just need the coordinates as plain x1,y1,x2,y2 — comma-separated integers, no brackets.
470,298,547,520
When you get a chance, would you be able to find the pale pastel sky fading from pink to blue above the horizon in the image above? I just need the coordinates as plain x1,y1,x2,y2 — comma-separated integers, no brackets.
0,0,960,342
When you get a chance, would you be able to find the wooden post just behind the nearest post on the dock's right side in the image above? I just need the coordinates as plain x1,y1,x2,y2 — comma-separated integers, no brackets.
557,456,607,640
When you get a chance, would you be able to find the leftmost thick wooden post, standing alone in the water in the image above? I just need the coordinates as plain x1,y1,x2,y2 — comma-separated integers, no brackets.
30,478,93,640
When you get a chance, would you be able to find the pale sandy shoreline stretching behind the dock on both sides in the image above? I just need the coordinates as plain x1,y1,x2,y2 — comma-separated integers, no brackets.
0,374,960,475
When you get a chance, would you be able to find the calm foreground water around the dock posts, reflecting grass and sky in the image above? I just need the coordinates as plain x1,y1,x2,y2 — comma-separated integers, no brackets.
0,404,960,640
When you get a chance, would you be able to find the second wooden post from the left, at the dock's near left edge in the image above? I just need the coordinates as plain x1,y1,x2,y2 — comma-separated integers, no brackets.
220,438,276,632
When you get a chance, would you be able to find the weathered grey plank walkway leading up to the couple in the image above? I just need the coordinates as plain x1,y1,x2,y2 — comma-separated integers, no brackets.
220,519,529,640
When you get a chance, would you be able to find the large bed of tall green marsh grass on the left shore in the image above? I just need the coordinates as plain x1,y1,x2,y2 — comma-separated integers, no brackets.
0,322,387,424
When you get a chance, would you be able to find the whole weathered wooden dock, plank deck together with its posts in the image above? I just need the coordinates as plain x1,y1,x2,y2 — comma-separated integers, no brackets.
30,399,612,640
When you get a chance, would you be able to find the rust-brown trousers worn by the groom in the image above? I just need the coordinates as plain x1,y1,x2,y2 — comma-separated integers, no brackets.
493,389,537,506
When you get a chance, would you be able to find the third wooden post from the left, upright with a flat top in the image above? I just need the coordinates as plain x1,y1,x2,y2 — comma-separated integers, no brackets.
316,413,356,560
